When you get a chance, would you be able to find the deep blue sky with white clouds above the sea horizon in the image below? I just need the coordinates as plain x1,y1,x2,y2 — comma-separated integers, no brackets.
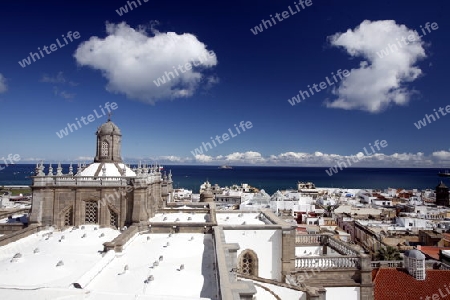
0,0,450,168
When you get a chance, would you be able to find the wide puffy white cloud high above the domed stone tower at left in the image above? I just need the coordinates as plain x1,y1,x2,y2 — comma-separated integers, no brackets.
74,22,217,104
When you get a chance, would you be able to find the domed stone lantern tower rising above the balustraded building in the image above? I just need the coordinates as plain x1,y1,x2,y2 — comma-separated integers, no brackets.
94,118,122,163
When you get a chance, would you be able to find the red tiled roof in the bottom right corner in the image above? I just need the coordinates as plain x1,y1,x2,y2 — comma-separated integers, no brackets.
372,268,450,300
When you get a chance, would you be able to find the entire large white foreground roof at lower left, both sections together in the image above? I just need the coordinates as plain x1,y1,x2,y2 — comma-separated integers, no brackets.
0,229,218,300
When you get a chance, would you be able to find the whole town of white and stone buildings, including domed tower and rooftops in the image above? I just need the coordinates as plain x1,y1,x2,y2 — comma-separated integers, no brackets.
0,120,450,300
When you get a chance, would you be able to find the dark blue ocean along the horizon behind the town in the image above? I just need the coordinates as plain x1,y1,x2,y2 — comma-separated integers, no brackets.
0,164,450,195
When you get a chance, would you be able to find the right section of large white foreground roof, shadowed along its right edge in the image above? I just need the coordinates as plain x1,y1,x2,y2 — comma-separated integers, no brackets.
86,233,218,300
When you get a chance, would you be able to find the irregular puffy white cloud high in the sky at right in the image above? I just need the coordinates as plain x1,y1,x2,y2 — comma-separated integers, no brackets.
326,20,426,113
